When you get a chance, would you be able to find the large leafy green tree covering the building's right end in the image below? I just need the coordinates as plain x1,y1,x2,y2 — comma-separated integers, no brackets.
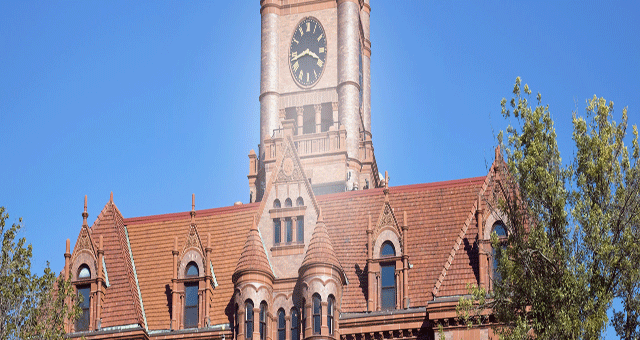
459,78,640,339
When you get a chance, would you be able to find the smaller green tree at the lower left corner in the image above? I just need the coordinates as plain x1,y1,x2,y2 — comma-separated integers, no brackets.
0,207,79,340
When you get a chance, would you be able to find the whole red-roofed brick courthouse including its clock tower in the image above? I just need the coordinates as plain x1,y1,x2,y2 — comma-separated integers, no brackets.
64,0,504,340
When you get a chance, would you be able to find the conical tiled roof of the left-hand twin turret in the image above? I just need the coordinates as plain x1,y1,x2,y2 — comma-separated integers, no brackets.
233,216,273,282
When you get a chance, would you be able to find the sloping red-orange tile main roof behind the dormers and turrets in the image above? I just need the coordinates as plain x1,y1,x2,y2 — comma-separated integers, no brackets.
82,173,486,330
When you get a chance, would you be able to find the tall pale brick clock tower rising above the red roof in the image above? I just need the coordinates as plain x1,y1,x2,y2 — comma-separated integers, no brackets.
248,0,380,202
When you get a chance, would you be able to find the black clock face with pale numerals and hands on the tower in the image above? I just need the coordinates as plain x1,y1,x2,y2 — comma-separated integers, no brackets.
289,17,327,87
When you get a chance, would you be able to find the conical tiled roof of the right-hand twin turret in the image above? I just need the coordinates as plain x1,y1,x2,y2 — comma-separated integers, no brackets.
300,209,344,274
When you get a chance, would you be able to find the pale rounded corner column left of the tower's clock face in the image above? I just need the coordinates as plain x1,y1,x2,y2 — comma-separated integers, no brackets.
260,7,280,146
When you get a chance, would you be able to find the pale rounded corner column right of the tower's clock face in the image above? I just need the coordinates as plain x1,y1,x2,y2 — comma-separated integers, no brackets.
338,0,360,159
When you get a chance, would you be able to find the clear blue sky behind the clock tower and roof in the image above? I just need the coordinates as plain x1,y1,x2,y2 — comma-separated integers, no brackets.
0,0,640,338
